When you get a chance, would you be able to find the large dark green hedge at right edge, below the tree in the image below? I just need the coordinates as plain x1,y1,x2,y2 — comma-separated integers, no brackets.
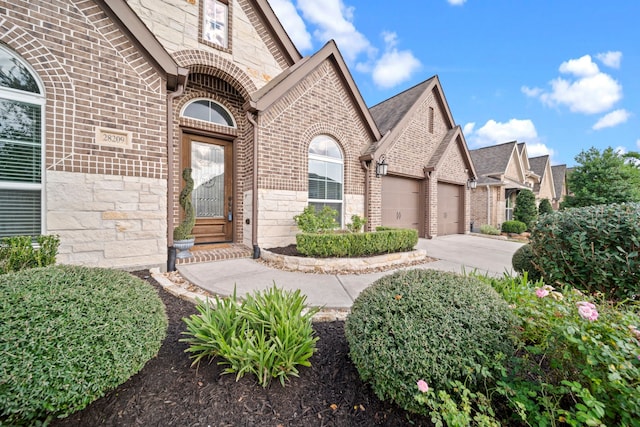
531,203,640,300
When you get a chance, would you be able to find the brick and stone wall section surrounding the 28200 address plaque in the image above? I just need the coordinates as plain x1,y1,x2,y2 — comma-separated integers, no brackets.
0,0,167,268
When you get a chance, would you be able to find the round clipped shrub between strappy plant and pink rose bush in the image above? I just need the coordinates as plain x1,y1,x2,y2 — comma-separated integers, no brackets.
345,269,515,413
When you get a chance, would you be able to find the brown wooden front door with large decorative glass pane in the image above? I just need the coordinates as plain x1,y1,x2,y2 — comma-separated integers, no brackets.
182,134,234,244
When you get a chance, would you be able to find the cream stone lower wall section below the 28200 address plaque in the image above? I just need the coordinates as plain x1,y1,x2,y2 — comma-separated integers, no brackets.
46,171,167,269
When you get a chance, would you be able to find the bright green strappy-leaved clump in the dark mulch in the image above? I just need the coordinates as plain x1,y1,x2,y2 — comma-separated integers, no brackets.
180,284,318,387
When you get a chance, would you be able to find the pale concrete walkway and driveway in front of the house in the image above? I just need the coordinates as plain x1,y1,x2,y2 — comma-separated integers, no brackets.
178,234,522,310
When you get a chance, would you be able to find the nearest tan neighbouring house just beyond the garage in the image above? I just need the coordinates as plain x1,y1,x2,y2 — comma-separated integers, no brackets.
470,141,540,230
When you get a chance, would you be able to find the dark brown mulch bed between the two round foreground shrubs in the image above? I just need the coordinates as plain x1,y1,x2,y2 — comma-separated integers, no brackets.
52,271,432,427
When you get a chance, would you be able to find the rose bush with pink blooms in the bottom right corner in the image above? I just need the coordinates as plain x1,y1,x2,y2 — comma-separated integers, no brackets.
482,277,640,426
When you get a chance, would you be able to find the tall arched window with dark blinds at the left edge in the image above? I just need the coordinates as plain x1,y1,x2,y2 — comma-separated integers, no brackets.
0,46,45,237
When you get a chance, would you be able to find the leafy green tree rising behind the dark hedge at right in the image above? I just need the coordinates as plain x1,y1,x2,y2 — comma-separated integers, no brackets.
561,147,640,209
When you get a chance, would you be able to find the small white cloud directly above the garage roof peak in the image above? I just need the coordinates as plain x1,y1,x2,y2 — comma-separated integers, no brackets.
372,32,422,89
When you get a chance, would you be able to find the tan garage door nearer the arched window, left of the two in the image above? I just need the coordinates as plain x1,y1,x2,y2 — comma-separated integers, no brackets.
382,176,422,235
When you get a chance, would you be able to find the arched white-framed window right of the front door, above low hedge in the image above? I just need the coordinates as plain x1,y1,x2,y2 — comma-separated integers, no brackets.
309,135,344,226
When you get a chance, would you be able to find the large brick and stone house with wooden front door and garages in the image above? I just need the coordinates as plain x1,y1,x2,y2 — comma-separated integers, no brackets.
0,0,476,269
